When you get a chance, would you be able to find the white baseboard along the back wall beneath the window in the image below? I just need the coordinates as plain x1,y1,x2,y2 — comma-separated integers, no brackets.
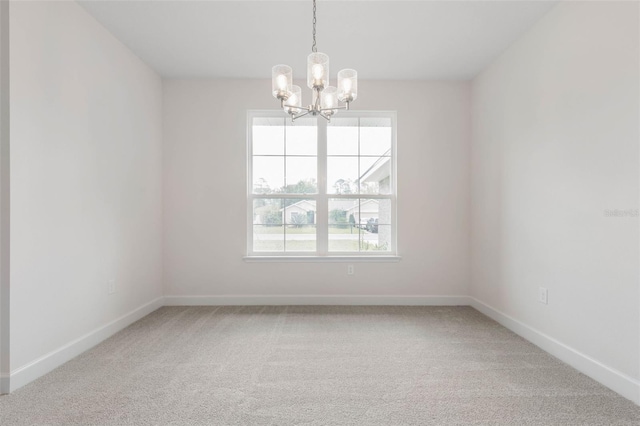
164,295,470,306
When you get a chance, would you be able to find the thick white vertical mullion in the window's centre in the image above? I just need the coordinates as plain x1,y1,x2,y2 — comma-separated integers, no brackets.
316,120,329,256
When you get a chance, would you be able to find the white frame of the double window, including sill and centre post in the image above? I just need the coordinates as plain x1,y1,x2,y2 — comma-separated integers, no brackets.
244,110,400,262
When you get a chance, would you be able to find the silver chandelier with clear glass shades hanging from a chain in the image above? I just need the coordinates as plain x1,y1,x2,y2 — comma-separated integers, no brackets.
271,0,358,121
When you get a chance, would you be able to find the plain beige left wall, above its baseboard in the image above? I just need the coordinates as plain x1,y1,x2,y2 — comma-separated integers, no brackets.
11,2,162,372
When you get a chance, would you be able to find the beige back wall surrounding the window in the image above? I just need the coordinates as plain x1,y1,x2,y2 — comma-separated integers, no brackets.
164,80,470,296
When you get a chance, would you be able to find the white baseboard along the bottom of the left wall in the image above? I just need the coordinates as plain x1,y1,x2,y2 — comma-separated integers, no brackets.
7,297,163,392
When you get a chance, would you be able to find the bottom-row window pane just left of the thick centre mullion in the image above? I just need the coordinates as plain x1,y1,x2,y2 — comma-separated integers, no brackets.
284,199,316,252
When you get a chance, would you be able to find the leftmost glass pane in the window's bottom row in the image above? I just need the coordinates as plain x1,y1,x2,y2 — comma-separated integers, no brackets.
253,198,285,251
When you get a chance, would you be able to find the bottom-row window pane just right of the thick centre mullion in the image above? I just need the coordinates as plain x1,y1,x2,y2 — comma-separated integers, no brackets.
328,198,360,252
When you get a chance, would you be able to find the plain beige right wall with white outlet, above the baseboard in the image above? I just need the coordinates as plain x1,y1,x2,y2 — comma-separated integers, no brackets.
471,2,640,384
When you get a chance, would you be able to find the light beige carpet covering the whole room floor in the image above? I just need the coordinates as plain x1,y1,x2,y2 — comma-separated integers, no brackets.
0,306,640,426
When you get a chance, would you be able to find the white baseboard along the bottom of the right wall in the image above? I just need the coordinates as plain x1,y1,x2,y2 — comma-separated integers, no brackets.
469,297,640,405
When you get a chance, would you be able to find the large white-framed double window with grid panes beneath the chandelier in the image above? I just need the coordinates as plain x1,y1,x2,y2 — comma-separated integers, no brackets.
247,111,396,257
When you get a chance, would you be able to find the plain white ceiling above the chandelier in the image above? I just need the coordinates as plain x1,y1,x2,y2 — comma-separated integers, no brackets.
79,0,557,79
